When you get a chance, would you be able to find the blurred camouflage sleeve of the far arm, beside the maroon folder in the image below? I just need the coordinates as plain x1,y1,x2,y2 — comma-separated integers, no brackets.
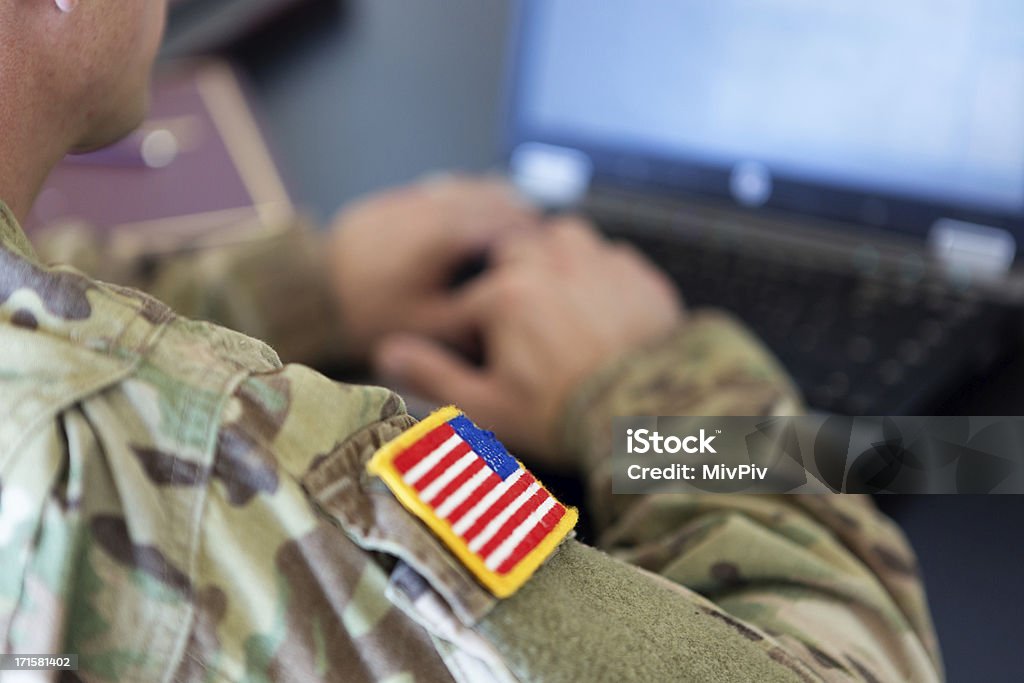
34,218,347,366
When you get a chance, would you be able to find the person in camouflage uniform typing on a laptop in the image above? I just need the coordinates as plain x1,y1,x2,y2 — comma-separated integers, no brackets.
0,0,941,682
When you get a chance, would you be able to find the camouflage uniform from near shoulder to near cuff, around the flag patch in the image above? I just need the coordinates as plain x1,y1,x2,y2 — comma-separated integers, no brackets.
0,204,941,682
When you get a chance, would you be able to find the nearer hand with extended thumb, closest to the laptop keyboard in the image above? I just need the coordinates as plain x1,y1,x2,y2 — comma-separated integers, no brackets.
375,219,683,469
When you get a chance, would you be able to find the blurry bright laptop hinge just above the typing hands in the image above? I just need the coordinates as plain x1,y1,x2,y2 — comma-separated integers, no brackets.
509,142,594,208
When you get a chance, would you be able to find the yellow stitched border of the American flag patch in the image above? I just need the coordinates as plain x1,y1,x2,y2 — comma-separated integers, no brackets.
367,405,580,598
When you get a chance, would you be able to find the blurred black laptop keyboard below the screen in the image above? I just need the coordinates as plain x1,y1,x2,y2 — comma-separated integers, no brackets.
606,226,1011,415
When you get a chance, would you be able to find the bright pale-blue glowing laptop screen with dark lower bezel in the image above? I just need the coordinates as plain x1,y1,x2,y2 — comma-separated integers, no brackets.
510,0,1024,242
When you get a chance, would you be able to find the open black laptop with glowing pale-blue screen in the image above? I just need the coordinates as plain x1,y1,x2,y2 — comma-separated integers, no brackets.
505,0,1024,415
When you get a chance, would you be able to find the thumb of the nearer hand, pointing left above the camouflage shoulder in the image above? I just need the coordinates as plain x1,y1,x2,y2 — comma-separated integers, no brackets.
374,335,490,410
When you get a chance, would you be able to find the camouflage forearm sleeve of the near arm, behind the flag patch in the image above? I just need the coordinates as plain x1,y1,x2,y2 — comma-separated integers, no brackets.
563,312,941,681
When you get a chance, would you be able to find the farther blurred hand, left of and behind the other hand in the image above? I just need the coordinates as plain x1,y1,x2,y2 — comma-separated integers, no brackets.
328,177,540,359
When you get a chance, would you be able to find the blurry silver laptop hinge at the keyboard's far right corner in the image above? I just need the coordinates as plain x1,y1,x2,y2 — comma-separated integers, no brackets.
928,218,1017,280
